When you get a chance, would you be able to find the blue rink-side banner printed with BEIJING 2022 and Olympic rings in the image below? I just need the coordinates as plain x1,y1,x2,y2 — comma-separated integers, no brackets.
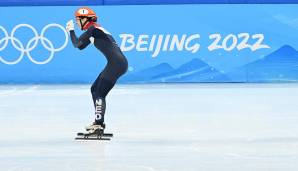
0,5,298,83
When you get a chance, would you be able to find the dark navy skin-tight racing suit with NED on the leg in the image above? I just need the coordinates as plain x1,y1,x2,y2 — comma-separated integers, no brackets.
70,26,128,124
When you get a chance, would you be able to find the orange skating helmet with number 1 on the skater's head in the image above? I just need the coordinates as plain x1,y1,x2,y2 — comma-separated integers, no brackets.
75,7,97,30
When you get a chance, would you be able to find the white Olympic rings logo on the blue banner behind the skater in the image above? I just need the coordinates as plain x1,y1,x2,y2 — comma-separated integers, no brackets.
0,23,68,65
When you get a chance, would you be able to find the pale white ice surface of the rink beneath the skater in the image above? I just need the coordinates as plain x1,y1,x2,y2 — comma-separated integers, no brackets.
0,84,298,171
